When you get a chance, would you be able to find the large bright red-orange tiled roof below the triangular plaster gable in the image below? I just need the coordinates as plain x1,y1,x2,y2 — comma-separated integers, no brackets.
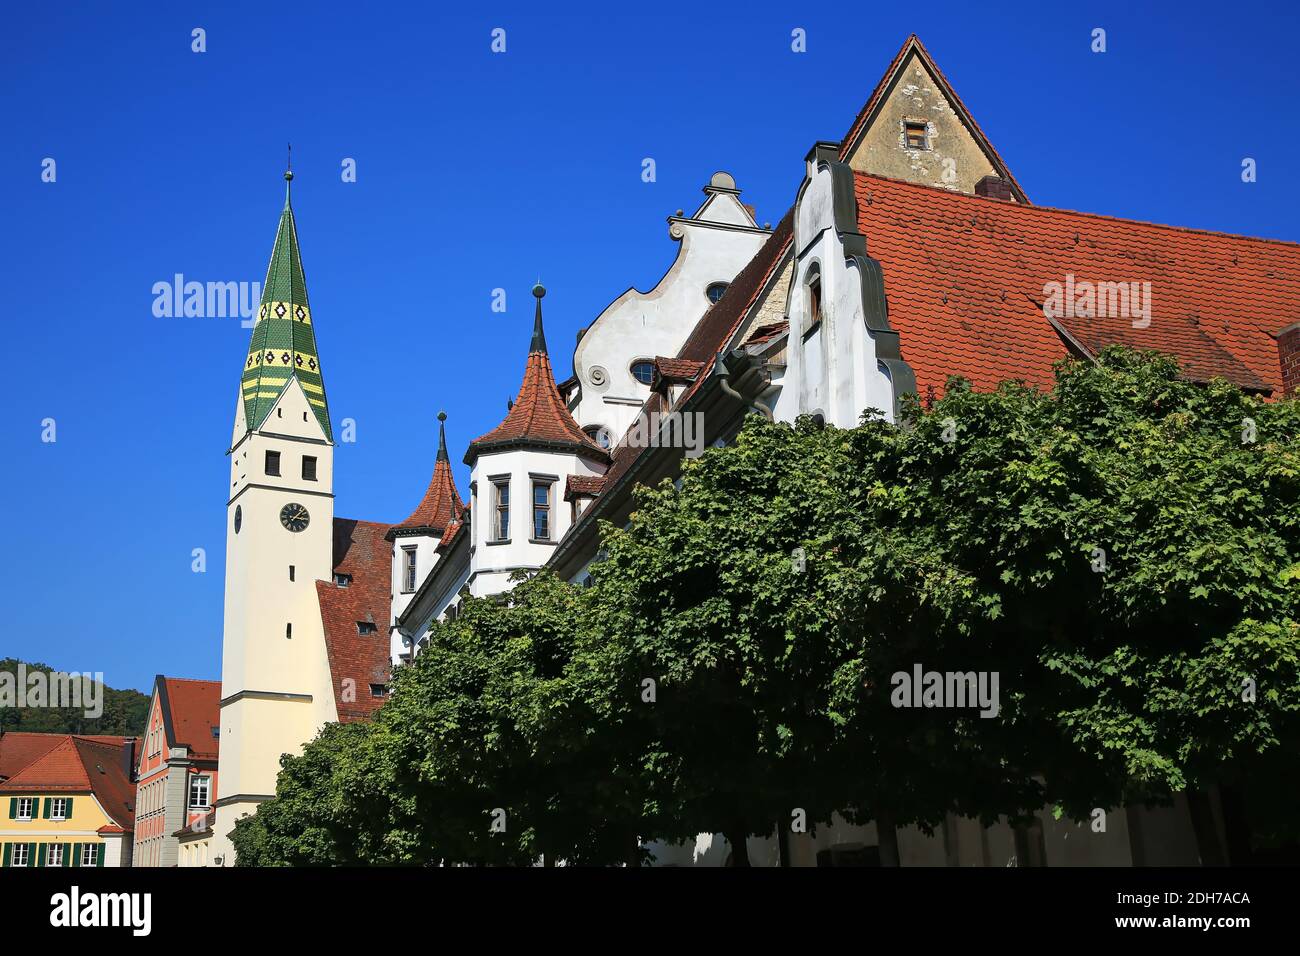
854,173,1300,397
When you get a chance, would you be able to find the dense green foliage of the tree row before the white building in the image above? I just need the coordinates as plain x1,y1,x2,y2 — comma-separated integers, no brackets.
241,350,1300,864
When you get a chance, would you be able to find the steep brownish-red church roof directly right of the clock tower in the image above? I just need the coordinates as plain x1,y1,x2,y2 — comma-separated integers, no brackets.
316,518,393,723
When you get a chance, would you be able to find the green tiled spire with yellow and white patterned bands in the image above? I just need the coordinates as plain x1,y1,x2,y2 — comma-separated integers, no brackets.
243,172,334,441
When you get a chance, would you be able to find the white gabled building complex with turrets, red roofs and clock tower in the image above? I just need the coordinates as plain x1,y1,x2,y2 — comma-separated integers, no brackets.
215,36,1300,865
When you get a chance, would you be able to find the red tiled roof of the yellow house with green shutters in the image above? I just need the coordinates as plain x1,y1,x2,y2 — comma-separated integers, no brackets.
0,734,135,830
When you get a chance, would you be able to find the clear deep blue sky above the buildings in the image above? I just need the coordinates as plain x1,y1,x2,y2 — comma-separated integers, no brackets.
0,0,1300,689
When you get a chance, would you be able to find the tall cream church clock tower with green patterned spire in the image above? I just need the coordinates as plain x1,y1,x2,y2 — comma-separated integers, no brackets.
212,172,338,866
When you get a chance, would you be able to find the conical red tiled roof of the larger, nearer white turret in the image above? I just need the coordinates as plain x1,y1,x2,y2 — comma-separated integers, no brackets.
465,286,608,464
